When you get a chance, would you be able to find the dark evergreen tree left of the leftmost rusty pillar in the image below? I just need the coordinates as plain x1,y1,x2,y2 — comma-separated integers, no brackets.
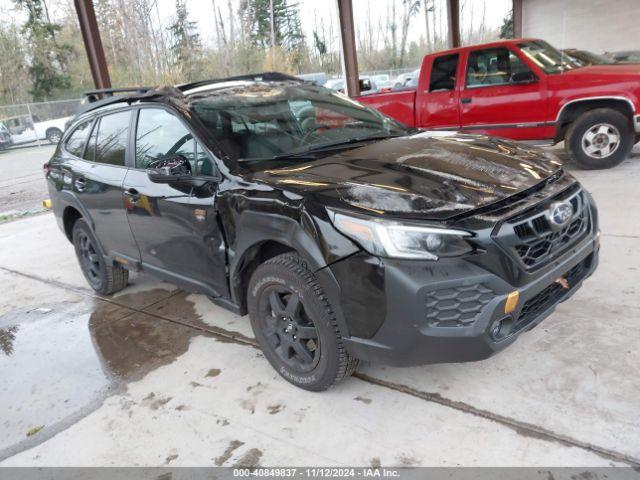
14,0,73,100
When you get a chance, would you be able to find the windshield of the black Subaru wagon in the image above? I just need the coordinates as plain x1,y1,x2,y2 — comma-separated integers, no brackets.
186,82,409,164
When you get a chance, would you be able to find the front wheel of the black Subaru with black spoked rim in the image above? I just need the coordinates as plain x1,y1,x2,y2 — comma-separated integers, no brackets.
247,253,358,392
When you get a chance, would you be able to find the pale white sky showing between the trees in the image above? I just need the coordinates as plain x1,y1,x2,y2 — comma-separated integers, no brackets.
0,0,512,51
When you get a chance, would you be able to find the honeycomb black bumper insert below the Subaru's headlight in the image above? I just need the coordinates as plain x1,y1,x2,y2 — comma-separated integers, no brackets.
426,283,495,327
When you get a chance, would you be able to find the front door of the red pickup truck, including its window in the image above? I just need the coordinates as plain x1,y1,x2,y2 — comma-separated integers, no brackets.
460,47,549,140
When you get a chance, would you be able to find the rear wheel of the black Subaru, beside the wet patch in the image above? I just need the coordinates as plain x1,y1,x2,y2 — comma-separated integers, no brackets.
71,218,129,295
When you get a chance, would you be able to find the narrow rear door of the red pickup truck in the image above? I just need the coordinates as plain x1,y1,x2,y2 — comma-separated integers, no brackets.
416,53,460,130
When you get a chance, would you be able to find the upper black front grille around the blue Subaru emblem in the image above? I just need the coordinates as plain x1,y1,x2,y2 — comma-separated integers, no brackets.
505,191,589,268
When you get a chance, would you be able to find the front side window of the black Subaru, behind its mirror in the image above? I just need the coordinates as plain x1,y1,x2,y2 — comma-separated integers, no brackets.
136,108,196,172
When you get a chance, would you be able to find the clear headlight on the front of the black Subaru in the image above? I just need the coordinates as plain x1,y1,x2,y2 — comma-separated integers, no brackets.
329,210,473,260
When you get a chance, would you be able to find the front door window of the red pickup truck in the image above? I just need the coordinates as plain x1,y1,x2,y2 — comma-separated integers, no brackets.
466,47,530,87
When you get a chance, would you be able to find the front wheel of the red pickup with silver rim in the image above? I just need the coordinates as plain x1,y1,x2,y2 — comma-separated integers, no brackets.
565,108,634,170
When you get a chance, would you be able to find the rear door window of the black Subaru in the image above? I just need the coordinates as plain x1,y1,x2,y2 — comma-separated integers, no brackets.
94,111,131,166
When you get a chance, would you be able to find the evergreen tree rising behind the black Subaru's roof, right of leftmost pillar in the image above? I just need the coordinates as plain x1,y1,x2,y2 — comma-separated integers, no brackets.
168,0,201,80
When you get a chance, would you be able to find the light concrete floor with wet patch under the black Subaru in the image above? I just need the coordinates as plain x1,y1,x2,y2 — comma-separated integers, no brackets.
0,145,640,467
